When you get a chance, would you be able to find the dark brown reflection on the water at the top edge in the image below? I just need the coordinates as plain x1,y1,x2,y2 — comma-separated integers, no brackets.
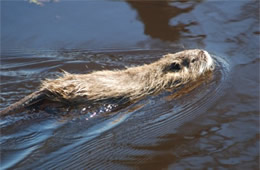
127,0,198,41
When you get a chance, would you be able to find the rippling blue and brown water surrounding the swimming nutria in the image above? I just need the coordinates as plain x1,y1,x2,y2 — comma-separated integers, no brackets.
0,0,260,169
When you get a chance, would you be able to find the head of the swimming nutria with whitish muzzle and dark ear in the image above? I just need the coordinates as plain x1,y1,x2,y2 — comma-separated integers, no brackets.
157,49,214,87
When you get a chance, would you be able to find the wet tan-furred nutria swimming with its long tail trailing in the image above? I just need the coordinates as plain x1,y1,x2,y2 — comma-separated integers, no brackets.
0,49,214,116
